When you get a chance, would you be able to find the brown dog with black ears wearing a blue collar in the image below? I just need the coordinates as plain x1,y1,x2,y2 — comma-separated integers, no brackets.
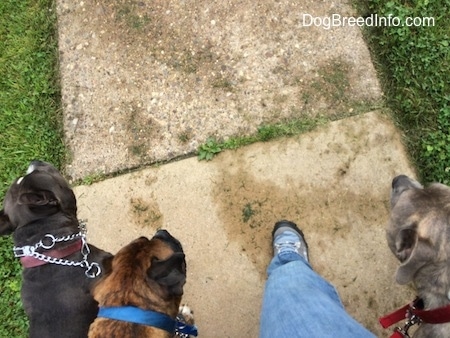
89,230,186,338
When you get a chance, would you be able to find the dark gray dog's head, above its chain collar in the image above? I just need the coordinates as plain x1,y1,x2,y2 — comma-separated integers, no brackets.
0,161,77,235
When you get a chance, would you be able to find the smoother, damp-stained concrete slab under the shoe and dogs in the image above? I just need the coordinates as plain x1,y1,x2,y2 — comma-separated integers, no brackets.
75,112,414,338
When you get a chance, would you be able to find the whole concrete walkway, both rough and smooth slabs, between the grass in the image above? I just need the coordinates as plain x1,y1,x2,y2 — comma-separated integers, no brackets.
57,0,414,338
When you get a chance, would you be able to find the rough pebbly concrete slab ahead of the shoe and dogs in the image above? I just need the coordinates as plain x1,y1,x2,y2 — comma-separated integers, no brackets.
56,0,382,179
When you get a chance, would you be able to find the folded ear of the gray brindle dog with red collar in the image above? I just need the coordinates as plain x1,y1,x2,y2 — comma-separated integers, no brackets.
395,229,435,285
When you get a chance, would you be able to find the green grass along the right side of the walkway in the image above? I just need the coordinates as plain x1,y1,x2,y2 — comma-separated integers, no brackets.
358,0,450,184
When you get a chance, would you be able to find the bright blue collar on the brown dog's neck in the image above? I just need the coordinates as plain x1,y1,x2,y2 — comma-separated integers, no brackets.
97,306,198,336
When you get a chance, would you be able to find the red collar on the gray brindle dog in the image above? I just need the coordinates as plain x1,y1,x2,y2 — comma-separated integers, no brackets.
379,298,450,337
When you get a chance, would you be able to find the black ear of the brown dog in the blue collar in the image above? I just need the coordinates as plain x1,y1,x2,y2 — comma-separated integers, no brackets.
147,252,186,296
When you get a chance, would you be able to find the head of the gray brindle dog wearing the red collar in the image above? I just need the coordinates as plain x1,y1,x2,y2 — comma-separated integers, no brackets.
387,175,450,286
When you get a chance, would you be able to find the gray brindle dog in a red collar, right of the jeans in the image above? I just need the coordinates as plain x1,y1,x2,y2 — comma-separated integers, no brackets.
387,175,450,337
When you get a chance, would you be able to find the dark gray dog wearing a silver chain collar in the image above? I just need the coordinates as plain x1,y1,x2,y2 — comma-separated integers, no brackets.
0,161,111,338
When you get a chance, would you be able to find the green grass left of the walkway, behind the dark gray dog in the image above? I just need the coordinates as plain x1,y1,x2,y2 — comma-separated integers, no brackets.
0,0,65,337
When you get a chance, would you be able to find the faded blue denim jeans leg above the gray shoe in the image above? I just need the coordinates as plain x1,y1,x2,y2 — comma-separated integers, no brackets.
259,252,375,338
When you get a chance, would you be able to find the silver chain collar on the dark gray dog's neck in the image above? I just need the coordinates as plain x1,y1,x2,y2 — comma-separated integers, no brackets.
13,220,101,278
